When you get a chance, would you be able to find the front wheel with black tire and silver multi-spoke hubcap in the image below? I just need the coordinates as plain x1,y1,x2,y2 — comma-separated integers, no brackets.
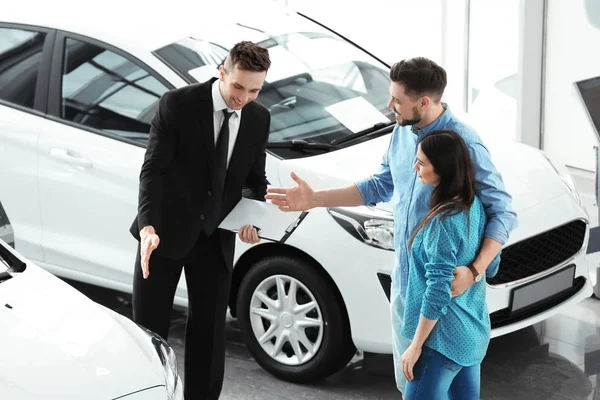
237,256,356,383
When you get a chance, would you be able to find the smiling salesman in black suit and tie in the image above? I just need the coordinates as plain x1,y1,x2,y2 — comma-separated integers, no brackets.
130,42,271,400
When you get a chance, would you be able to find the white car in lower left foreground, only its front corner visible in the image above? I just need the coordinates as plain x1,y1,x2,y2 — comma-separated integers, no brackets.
0,236,183,400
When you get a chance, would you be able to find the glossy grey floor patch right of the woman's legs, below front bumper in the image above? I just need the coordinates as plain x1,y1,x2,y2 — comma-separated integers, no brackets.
482,298,600,400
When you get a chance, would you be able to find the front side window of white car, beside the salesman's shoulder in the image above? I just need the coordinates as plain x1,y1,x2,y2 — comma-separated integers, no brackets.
61,39,168,142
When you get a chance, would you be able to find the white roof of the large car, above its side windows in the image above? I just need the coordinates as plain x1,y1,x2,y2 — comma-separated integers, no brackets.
0,0,293,51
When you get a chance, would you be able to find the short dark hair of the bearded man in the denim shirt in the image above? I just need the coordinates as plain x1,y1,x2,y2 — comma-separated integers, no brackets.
390,57,447,101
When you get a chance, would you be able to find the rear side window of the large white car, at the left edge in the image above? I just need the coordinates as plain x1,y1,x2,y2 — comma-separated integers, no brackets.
0,28,46,108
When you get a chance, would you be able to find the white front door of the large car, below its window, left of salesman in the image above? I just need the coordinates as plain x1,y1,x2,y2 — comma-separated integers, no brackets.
39,121,144,284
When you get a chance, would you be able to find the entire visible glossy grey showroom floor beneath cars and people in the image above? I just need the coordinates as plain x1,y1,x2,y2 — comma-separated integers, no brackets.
69,281,600,400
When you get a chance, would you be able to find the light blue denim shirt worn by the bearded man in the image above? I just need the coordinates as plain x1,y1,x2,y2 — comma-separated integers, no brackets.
356,104,517,298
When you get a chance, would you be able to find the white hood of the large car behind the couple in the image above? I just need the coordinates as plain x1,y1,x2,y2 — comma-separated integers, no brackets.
279,135,568,212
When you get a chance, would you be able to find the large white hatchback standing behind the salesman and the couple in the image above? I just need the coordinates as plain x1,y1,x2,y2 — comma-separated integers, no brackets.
0,3,597,382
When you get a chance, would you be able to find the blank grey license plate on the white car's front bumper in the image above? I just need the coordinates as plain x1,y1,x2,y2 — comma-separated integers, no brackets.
510,264,575,313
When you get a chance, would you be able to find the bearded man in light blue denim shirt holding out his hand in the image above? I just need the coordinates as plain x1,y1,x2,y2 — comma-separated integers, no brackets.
266,57,517,391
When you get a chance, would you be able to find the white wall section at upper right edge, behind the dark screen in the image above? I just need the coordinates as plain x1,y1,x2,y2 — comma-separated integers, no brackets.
542,0,600,171
